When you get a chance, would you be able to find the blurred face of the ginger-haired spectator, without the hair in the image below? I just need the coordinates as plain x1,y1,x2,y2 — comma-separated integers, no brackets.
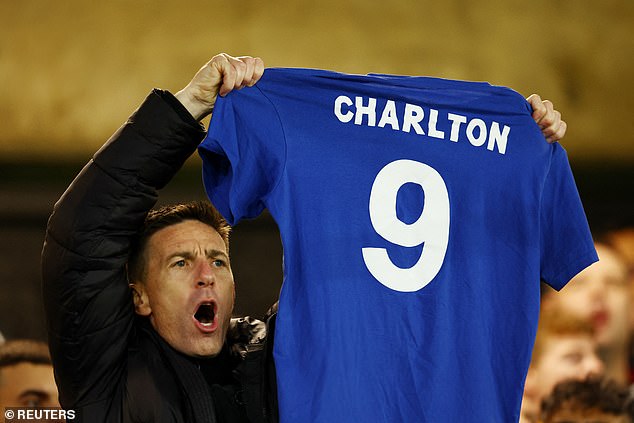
531,334,603,402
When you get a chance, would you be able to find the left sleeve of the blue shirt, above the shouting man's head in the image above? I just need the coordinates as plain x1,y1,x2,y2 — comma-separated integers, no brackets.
198,85,286,225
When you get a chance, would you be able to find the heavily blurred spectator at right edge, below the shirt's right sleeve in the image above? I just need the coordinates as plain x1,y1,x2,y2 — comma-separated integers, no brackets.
542,242,631,384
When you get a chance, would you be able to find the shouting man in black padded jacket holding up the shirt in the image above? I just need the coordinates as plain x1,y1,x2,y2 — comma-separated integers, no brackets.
42,54,566,423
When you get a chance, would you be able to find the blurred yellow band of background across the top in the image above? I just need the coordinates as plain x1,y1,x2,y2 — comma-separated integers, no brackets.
0,0,634,160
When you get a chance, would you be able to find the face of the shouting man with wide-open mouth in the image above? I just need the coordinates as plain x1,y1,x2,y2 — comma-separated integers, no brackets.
135,220,235,357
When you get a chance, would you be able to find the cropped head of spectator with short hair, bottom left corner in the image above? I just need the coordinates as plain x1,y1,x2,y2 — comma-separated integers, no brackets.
0,339,59,407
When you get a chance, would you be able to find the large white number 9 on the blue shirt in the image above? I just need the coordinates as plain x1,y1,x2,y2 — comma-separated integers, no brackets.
361,160,449,292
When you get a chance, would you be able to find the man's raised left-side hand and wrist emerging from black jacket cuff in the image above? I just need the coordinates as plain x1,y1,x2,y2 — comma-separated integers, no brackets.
175,53,264,120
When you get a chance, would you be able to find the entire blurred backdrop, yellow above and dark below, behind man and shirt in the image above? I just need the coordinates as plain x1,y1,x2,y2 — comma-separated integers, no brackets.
0,0,634,337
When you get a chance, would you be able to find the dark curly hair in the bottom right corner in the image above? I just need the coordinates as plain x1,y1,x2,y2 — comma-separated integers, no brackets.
541,376,634,422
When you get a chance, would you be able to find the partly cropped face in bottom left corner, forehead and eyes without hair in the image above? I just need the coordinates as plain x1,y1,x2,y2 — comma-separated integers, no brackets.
0,362,59,407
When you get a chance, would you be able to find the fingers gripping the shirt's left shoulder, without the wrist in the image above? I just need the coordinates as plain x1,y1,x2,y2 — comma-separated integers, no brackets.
211,53,264,96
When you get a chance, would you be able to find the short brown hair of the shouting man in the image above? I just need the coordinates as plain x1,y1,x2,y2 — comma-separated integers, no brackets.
128,201,231,282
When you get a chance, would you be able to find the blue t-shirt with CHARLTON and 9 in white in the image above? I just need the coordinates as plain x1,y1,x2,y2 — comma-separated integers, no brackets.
199,69,597,423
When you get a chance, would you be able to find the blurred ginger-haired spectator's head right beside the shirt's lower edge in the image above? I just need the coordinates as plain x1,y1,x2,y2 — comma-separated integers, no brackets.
520,309,603,423
